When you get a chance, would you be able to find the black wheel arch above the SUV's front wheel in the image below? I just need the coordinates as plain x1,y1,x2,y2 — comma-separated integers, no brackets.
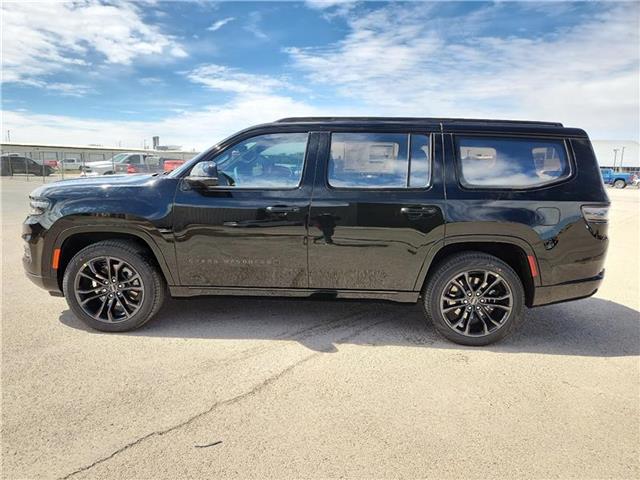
54,227,175,288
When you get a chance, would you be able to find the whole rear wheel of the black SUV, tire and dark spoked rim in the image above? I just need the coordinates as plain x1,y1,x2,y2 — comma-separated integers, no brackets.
422,252,524,346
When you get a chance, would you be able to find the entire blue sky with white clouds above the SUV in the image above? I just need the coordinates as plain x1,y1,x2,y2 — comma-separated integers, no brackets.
2,0,640,149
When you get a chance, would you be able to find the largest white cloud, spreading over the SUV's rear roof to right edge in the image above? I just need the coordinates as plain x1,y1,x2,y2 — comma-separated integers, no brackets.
287,3,640,138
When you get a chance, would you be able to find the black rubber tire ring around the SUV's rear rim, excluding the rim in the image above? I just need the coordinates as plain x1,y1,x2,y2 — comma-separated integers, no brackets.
423,254,524,346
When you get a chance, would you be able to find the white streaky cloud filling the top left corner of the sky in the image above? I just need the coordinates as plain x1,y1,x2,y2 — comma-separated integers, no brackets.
1,0,187,83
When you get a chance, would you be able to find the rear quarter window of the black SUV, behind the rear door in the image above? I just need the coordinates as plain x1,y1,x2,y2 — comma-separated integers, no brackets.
456,136,571,188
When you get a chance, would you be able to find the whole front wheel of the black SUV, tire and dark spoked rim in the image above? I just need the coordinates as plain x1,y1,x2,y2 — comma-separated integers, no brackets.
62,240,166,332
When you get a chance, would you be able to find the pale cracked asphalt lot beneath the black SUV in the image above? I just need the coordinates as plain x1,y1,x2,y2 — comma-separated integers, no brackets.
1,179,640,479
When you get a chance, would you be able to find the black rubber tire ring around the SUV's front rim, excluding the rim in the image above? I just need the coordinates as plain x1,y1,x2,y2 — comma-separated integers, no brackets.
62,245,158,332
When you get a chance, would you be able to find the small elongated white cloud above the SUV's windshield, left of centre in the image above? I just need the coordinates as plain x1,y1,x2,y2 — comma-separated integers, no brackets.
186,64,293,93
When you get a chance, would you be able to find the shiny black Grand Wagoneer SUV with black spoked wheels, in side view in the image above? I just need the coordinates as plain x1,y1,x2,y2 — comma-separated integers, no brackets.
23,118,609,345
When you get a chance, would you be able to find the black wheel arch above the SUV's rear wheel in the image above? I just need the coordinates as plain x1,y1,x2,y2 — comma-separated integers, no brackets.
415,235,540,307
